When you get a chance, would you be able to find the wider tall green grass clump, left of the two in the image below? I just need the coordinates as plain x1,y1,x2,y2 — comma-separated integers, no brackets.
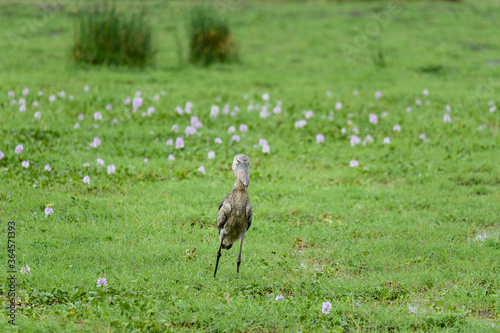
72,4,154,66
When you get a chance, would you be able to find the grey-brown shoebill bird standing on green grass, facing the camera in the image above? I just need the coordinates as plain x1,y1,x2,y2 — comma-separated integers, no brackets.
214,154,253,277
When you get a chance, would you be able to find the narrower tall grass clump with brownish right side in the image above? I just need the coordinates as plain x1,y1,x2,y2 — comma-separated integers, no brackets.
189,7,238,66
